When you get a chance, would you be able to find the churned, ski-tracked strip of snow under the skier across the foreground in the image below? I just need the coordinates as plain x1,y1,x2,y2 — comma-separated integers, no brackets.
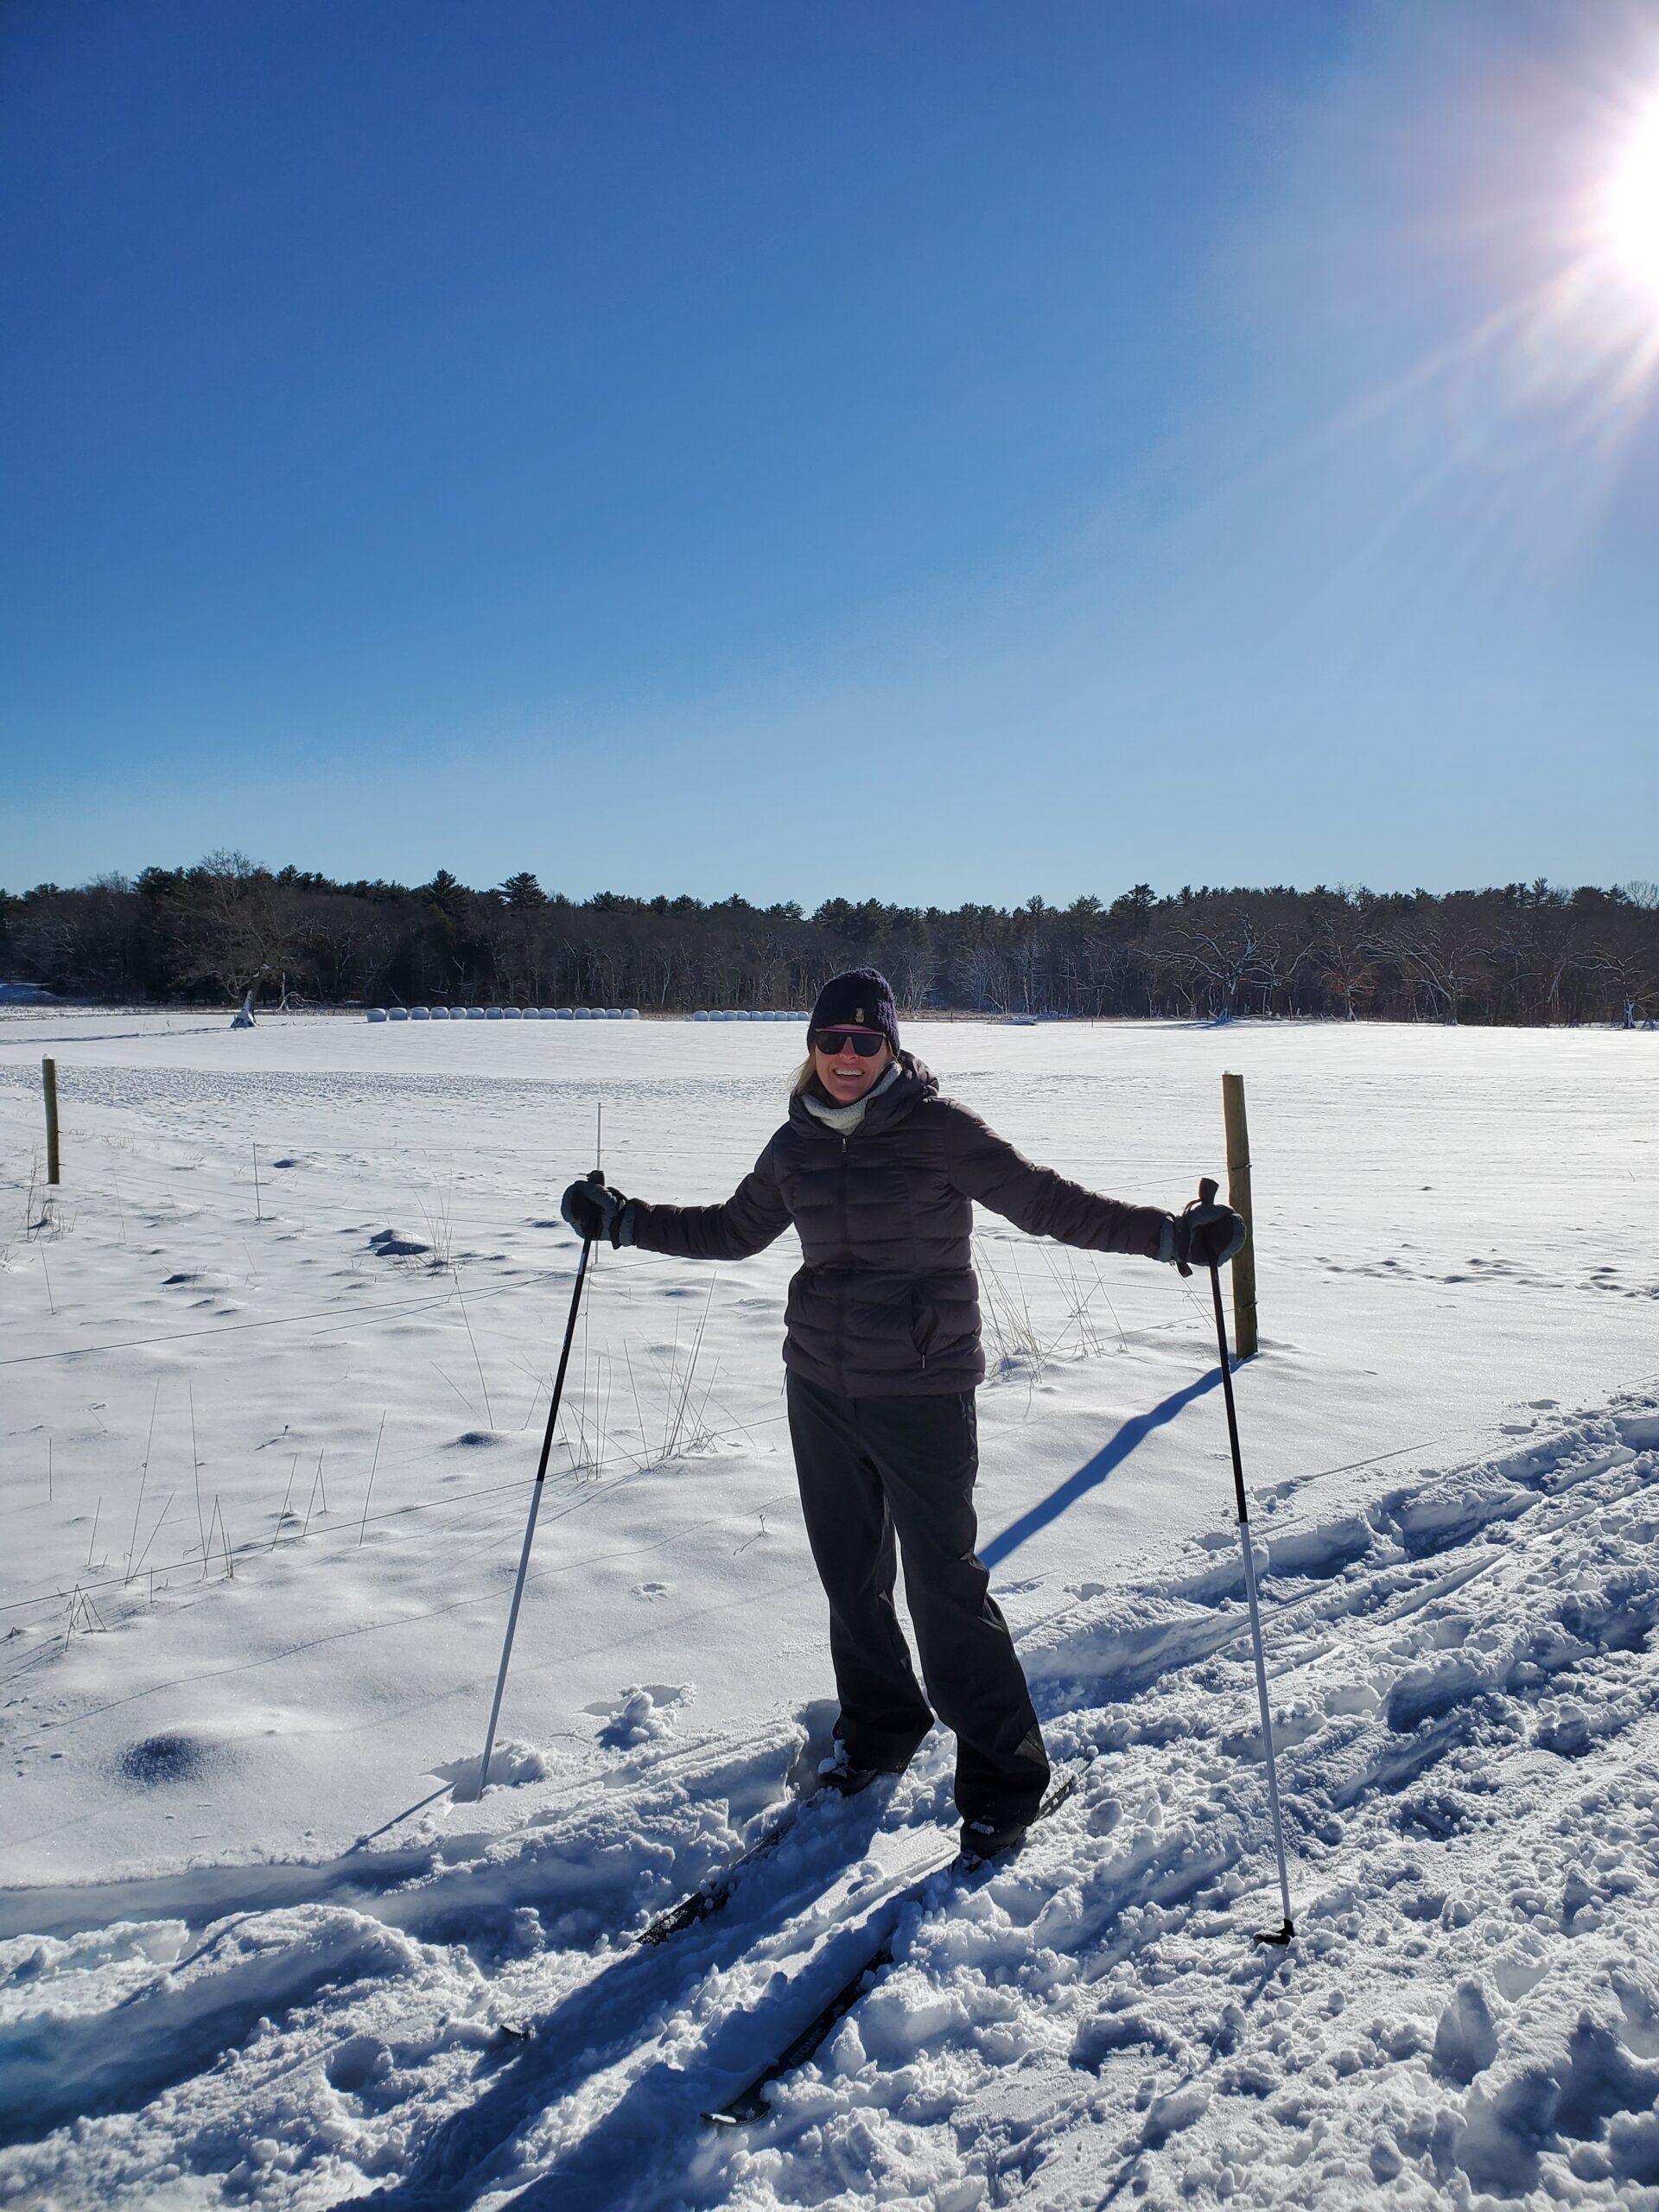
0,1402,1659,2212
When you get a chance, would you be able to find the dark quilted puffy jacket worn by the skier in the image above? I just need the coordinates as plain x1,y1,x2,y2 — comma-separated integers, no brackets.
631,1053,1168,1398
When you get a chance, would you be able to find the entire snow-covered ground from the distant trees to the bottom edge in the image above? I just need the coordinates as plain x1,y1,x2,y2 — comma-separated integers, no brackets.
0,1011,1659,2212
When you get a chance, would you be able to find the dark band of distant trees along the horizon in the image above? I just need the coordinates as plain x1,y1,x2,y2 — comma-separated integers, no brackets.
0,852,1659,1027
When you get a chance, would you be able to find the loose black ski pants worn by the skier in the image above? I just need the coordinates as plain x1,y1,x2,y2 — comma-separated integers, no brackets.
790,1374,1048,1821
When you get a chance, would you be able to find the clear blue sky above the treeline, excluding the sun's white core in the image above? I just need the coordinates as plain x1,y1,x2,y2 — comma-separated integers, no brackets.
0,0,1659,905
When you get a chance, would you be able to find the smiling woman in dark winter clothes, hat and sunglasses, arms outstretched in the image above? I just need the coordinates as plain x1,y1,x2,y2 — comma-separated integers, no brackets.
564,969,1243,1858
